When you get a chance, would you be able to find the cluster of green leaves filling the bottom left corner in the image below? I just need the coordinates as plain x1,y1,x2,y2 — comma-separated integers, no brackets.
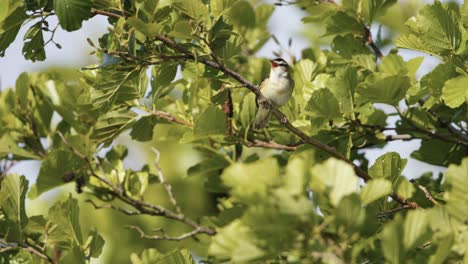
0,174,104,263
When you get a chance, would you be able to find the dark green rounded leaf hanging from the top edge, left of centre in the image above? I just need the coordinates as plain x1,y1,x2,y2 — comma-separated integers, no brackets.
54,0,93,31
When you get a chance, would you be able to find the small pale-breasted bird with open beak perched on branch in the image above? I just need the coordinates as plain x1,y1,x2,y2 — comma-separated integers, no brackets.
254,58,294,129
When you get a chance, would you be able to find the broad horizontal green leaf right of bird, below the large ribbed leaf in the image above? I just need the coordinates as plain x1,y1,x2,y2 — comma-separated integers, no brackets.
357,75,410,105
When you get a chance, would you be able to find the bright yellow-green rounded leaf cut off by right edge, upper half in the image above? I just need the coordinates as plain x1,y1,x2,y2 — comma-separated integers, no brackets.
442,75,468,108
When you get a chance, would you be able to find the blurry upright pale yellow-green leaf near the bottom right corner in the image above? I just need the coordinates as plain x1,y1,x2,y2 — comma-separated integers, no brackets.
403,209,431,251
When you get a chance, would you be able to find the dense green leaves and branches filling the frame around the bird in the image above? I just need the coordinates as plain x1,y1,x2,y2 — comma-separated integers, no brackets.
0,0,468,263
